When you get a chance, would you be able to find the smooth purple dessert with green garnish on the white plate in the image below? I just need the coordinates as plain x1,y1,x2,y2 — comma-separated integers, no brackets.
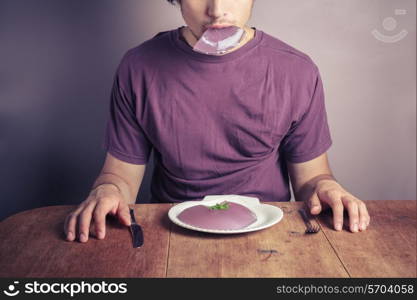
177,201,257,230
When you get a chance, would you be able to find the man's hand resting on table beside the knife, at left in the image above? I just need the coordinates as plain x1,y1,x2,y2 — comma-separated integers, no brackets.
64,184,130,243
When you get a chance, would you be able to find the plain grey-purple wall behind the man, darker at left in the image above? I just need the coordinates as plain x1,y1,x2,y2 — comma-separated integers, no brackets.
0,0,416,219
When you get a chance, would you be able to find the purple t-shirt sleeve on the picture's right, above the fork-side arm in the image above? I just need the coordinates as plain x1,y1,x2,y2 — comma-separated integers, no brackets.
280,68,332,163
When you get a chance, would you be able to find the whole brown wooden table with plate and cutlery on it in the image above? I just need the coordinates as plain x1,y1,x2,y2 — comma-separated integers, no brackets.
0,201,416,278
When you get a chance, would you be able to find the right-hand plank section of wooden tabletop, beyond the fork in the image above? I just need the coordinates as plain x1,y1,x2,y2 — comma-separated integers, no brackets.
319,200,416,278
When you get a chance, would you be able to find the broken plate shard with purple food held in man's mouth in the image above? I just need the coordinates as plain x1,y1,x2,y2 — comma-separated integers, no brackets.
193,26,246,55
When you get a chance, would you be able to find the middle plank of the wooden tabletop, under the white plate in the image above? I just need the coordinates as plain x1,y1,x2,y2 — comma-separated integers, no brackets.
167,203,348,277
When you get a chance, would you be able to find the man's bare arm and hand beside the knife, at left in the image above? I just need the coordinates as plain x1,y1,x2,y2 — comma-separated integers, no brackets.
64,153,146,242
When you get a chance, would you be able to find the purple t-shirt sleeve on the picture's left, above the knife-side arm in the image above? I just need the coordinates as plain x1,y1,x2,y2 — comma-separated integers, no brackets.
103,54,152,164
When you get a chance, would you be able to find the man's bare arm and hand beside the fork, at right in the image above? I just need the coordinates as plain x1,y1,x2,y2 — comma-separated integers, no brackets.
287,153,370,232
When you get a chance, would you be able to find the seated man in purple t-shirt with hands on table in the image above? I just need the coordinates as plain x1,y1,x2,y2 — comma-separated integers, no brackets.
64,0,370,242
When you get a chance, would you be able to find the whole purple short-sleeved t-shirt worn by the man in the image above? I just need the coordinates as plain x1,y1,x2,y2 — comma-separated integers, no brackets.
104,28,332,202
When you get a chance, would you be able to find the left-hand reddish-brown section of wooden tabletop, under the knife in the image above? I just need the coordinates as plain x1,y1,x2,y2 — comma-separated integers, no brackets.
0,204,171,277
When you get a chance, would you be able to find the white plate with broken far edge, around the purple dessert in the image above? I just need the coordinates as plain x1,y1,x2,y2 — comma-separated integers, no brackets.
168,195,284,234
